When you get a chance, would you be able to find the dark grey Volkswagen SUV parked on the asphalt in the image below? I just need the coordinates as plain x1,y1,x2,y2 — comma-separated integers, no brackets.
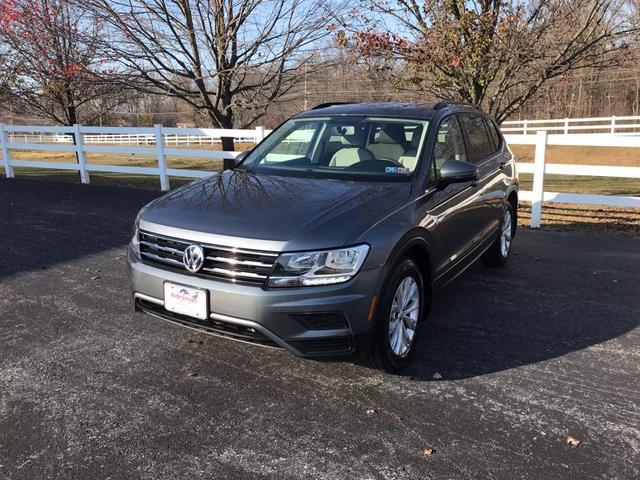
128,102,518,371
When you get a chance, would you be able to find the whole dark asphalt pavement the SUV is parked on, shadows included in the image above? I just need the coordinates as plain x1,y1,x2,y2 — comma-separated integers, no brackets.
0,179,640,480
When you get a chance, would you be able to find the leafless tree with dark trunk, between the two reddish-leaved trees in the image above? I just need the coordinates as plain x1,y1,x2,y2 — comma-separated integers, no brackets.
85,0,340,150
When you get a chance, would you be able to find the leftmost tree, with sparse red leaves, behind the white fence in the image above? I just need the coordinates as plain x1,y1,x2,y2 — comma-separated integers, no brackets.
0,0,122,125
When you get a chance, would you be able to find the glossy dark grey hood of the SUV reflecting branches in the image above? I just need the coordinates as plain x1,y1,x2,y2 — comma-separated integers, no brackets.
141,170,411,250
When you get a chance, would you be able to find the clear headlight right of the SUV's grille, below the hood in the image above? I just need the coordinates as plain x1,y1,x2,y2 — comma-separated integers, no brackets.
267,245,369,287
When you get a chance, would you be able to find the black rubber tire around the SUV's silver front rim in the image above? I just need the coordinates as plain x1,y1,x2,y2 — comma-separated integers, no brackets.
367,258,427,373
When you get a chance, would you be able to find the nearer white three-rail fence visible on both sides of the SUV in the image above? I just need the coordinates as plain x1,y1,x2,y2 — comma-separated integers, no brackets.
0,124,640,228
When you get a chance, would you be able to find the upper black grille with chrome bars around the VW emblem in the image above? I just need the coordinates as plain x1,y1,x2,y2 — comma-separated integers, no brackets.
139,231,278,285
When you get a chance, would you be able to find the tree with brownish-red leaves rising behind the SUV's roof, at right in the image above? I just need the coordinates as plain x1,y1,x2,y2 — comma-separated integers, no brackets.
342,0,638,121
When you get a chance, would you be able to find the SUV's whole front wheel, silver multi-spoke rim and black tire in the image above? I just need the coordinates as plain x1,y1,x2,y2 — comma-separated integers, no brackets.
369,258,425,373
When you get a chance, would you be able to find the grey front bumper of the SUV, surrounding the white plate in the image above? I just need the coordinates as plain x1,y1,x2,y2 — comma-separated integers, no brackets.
127,252,380,357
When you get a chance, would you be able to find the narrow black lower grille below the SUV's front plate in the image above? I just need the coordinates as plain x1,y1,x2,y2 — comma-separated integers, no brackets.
136,298,279,348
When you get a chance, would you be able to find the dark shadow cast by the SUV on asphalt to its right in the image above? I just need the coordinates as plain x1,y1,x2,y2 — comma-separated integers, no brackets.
402,253,640,381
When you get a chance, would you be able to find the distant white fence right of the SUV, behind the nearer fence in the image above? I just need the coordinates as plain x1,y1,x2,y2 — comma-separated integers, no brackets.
500,116,640,135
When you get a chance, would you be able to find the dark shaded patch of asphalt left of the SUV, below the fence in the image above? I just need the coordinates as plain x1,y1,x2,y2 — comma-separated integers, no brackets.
0,179,161,279
